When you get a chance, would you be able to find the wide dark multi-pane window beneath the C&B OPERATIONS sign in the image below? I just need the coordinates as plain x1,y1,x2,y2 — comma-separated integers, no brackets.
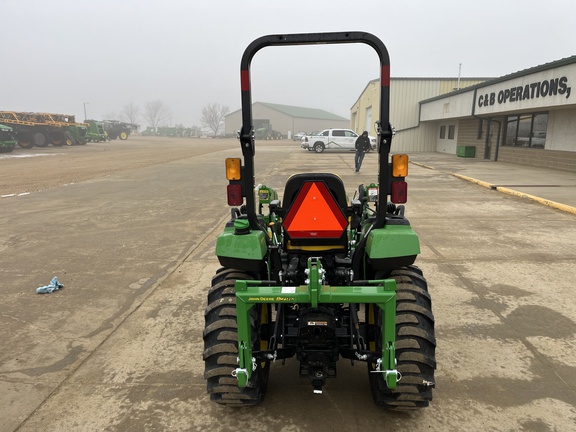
503,113,548,148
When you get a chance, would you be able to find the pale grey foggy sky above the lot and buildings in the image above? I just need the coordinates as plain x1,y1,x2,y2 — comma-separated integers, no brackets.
0,0,576,126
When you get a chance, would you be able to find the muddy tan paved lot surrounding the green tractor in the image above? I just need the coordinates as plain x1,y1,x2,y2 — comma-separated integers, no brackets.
0,137,576,432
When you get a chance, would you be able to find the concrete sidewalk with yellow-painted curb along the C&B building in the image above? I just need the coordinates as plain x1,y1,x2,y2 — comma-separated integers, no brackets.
409,153,576,215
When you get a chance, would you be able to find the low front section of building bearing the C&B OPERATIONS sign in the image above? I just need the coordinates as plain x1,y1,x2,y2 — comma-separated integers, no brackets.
420,56,576,172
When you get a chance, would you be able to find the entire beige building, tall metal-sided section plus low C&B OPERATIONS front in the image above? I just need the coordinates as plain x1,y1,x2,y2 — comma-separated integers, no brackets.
351,56,576,172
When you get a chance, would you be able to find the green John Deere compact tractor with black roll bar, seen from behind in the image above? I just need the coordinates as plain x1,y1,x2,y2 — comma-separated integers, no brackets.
203,32,436,410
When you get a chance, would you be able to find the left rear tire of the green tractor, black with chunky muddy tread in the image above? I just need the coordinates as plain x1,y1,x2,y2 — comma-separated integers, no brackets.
203,269,270,406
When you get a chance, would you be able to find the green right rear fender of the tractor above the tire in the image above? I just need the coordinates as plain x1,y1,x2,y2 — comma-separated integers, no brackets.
366,224,420,270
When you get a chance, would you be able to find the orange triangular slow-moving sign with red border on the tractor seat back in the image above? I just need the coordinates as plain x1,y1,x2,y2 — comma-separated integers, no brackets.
284,181,348,239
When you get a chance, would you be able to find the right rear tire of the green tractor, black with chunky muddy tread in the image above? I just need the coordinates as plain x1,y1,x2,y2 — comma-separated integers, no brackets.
368,266,436,411
